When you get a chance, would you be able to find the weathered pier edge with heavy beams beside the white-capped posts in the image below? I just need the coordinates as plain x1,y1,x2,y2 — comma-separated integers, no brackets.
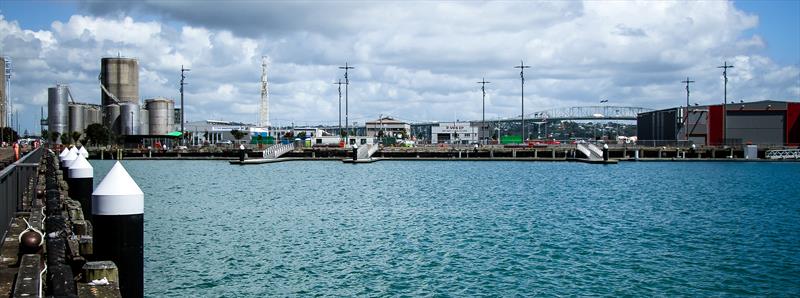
0,148,122,297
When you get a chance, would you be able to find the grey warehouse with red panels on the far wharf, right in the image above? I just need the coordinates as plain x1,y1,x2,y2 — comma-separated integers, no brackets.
636,100,800,146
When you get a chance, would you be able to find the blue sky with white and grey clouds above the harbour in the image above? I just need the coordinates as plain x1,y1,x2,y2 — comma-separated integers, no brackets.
0,0,800,131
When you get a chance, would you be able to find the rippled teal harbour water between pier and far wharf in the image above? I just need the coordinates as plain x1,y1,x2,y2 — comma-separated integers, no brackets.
92,161,800,297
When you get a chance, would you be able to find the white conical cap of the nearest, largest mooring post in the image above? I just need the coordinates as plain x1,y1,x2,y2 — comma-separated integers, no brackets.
92,162,144,215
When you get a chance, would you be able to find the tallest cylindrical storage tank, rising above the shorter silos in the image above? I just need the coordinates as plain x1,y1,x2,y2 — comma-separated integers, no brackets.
100,58,139,106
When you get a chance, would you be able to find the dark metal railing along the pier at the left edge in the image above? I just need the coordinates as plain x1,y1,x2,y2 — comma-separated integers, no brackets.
0,147,44,230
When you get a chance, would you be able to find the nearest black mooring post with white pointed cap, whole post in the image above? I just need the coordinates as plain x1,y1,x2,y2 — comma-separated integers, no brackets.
92,162,144,297
